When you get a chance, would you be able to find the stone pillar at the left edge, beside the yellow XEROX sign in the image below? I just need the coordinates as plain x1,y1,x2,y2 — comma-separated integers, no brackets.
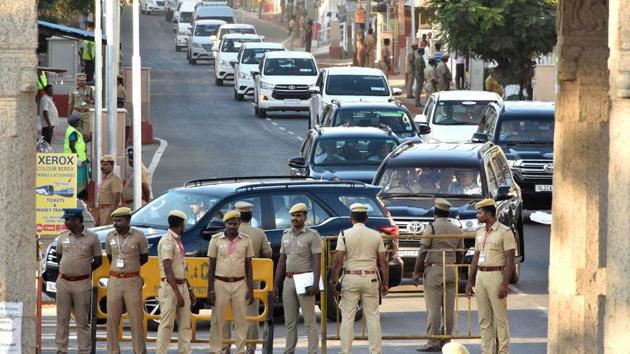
0,0,37,354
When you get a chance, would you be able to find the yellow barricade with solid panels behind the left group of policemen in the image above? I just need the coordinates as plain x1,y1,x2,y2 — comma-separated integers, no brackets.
92,256,273,353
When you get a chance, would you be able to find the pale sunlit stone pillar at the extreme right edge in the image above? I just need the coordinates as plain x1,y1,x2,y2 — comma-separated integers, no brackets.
603,0,630,354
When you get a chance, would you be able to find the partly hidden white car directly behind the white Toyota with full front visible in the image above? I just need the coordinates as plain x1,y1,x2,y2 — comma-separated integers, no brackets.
234,42,286,101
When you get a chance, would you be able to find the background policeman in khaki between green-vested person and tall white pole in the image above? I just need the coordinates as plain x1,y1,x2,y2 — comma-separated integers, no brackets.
96,155,122,226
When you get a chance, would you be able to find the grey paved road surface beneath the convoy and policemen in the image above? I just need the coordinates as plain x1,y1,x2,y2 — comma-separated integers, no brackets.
43,9,550,354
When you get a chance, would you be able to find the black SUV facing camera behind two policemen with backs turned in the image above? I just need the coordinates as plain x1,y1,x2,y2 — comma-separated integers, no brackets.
374,143,525,283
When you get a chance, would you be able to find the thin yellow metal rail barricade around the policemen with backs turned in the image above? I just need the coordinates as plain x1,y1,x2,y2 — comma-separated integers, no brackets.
321,232,481,353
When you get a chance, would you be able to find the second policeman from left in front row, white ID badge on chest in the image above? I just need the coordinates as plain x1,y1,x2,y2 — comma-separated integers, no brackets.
105,207,149,354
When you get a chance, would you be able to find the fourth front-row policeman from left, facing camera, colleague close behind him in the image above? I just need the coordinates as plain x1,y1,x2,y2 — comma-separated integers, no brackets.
208,210,254,354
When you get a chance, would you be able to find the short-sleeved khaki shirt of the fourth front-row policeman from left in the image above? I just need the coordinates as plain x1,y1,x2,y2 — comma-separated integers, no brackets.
208,232,254,278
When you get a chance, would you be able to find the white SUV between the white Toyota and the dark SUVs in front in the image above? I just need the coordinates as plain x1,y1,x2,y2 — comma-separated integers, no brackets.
311,67,402,117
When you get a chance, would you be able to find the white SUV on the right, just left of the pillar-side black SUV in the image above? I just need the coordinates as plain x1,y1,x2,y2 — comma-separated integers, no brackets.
414,91,501,143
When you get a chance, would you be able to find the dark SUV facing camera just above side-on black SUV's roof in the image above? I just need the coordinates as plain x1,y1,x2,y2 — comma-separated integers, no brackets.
289,126,400,183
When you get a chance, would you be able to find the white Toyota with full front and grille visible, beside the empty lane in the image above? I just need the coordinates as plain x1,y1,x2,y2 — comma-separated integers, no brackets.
253,52,317,118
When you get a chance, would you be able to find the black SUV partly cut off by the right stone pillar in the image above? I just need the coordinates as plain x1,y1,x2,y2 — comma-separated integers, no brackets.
473,101,555,209
